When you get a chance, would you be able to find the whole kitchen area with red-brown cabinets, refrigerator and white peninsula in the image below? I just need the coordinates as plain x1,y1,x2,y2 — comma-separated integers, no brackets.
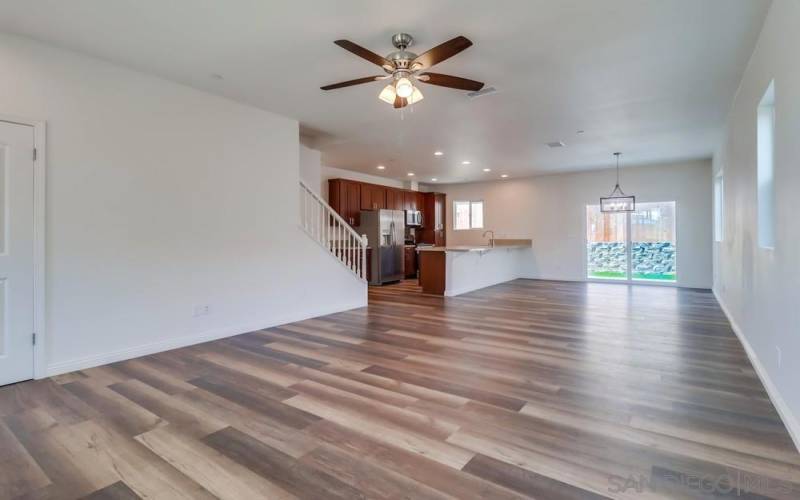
328,178,532,296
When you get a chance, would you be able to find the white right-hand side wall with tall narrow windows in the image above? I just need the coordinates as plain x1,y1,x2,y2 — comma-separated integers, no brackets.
714,0,800,448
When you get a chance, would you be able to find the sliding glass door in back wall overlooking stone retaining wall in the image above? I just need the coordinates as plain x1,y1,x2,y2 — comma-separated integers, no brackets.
586,201,677,283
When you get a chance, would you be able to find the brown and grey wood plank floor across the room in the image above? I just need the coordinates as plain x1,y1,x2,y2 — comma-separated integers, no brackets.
0,280,800,500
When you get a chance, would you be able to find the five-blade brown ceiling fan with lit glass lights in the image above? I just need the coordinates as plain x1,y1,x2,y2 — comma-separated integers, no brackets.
320,33,483,109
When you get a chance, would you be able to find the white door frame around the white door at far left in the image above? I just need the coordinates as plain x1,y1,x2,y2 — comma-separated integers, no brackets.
0,113,47,379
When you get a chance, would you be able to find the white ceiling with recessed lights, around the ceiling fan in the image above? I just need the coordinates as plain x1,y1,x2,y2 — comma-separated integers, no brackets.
0,0,769,182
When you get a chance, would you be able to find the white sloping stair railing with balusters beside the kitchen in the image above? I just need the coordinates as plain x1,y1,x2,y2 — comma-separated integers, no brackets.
300,181,367,282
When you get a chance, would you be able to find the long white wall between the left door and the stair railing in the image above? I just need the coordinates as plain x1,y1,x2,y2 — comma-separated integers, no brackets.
0,35,366,373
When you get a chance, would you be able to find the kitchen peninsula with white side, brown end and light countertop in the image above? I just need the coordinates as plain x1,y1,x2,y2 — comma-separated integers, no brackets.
417,239,533,297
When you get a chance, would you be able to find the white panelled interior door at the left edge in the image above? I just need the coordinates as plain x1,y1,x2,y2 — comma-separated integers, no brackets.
0,122,33,385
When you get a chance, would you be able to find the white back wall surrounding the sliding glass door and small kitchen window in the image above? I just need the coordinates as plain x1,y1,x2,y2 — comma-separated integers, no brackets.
436,160,712,288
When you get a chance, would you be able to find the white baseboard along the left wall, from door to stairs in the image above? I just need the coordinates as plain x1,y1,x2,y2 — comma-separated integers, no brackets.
46,298,367,377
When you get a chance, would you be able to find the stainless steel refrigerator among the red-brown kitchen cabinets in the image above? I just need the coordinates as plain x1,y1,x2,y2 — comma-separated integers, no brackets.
356,210,406,285
